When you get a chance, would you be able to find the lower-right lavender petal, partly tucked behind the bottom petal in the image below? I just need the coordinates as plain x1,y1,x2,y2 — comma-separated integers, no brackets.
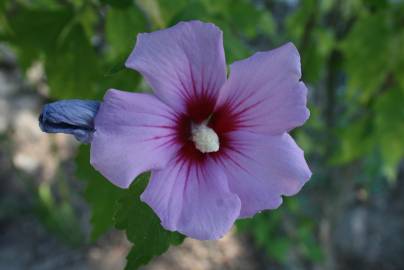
219,132,311,217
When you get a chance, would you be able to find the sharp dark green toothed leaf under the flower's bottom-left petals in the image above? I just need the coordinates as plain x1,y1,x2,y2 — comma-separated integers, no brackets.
115,174,184,270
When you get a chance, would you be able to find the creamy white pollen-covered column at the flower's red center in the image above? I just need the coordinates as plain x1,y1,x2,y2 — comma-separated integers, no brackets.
191,122,219,153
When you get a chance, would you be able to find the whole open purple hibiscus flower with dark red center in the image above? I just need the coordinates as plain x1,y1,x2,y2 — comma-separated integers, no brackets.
91,21,311,240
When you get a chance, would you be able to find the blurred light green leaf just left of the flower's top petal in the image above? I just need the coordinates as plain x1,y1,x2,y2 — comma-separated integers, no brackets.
105,5,147,57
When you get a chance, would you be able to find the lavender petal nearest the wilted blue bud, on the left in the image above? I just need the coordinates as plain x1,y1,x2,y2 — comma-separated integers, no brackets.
91,90,176,188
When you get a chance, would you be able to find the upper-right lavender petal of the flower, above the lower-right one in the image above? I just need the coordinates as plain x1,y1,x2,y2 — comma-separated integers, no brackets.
217,43,309,135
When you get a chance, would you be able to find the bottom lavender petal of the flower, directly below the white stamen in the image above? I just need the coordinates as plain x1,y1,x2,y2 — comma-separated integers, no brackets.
141,159,240,240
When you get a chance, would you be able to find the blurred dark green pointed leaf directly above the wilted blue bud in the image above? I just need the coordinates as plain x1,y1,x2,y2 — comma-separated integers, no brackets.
45,24,101,98
